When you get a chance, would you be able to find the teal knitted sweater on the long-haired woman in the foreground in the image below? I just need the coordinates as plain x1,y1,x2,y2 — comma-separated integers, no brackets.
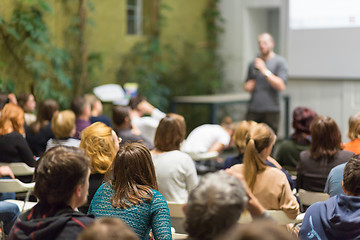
88,183,172,240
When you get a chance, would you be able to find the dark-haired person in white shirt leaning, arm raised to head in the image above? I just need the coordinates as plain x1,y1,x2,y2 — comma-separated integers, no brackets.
129,96,165,144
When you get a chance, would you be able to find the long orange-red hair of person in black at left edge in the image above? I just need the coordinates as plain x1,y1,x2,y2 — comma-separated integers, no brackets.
0,103,25,135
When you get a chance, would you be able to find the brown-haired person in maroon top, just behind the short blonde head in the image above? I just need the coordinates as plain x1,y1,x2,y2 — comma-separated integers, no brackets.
71,97,91,139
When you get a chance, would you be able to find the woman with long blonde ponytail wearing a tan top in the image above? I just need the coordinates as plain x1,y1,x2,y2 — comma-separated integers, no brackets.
230,123,299,219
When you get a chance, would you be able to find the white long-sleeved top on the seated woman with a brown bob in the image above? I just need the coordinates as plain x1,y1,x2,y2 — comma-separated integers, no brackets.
152,150,199,203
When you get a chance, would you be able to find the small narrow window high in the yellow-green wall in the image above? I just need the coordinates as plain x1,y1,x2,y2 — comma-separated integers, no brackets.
126,0,142,35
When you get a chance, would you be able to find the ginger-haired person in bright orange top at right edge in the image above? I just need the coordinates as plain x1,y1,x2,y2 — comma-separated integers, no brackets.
344,113,360,154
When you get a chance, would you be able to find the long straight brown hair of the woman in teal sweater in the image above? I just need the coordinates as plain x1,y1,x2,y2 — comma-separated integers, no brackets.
105,143,158,209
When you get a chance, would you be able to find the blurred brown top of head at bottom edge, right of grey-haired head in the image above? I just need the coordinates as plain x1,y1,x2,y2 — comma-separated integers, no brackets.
222,220,297,240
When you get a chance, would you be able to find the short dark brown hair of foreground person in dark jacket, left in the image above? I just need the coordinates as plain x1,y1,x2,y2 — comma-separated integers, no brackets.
34,146,90,205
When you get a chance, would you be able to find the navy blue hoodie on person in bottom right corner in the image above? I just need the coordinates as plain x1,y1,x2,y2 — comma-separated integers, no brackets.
299,195,360,240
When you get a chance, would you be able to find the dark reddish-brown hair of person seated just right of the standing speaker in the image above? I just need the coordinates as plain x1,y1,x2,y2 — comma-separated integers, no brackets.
291,107,317,142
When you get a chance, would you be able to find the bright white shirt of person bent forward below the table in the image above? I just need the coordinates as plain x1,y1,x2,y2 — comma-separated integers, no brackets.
181,124,230,153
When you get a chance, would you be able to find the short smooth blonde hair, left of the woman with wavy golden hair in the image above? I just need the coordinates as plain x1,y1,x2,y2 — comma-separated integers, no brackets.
51,110,75,138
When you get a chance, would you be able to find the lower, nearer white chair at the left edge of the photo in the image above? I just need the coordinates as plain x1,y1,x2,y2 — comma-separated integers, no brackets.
0,179,36,211
